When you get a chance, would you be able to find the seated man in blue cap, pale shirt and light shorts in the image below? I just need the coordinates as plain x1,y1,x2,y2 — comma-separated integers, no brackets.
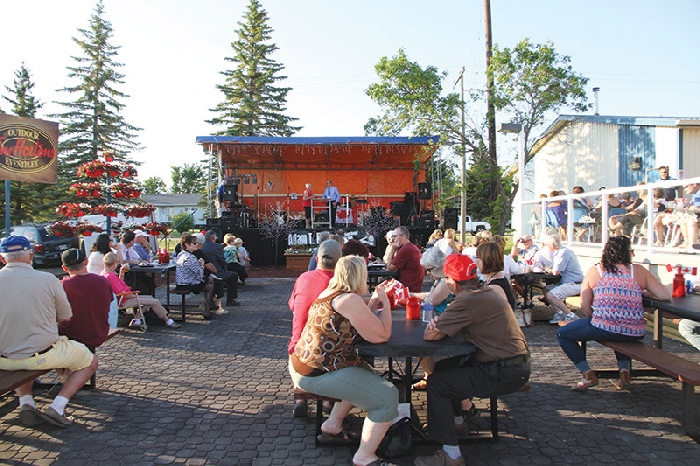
0,236,97,427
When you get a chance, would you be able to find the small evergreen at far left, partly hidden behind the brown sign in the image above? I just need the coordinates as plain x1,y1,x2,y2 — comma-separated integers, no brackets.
0,63,56,225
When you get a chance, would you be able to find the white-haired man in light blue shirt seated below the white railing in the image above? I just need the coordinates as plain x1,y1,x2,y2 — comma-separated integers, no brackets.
534,234,583,325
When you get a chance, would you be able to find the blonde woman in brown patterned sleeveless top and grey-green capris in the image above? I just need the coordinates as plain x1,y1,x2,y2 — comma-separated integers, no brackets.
289,256,399,465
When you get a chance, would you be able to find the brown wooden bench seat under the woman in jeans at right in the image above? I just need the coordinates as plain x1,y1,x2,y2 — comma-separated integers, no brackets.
595,341,700,438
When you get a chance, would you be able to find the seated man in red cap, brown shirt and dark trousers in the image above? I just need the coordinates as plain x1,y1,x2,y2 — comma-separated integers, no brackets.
415,254,530,466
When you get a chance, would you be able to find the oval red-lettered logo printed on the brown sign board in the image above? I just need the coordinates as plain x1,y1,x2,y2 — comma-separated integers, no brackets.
0,124,57,173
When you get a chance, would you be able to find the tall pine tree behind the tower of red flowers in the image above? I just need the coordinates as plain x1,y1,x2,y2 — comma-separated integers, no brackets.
54,0,141,184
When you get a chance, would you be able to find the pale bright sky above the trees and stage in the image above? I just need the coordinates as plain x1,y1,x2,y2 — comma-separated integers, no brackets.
0,0,700,183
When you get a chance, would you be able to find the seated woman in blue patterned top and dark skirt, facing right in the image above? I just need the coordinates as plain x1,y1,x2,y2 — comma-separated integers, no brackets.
175,235,214,320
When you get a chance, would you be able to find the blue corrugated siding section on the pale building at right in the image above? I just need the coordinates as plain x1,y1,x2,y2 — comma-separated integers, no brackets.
609,125,656,187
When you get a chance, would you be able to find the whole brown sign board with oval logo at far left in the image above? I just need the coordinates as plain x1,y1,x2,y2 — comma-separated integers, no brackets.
0,114,58,184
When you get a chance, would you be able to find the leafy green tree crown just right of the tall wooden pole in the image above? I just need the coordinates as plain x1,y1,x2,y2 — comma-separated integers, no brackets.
487,39,590,158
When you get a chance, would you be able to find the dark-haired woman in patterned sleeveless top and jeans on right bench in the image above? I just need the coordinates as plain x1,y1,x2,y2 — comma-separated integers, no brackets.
557,236,671,391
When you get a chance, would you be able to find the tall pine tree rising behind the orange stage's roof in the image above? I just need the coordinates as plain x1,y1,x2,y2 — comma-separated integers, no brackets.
206,0,301,136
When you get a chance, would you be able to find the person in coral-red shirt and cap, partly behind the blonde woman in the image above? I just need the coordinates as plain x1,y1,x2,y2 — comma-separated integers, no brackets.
287,239,343,417
